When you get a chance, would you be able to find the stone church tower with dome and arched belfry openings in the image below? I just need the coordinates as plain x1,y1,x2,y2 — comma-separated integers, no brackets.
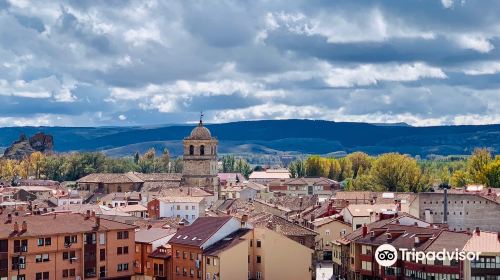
182,115,219,192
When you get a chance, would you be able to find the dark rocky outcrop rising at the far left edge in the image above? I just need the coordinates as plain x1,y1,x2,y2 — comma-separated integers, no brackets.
3,132,54,160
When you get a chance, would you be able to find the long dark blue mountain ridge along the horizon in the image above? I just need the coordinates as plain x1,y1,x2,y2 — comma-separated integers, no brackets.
0,120,500,156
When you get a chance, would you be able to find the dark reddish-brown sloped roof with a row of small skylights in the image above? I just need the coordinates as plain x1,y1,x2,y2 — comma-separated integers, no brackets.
169,216,233,247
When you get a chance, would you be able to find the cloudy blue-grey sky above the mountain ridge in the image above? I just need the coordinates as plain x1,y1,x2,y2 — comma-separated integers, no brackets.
0,0,500,126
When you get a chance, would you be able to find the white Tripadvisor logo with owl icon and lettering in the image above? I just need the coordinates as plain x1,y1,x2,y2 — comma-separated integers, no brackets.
375,244,481,266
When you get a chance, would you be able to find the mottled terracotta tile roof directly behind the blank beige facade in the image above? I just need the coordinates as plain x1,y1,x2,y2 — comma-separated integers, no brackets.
248,213,318,236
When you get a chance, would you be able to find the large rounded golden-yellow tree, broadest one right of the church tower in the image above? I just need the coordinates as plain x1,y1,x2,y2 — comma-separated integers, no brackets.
370,153,427,192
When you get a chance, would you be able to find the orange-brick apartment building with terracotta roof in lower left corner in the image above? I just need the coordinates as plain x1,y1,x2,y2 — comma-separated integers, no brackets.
0,212,135,280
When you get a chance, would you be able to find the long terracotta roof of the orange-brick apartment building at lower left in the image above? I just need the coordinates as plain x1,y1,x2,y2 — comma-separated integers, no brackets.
0,213,135,238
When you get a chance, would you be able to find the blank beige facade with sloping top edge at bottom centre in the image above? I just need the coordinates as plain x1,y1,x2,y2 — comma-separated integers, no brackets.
244,228,314,280
